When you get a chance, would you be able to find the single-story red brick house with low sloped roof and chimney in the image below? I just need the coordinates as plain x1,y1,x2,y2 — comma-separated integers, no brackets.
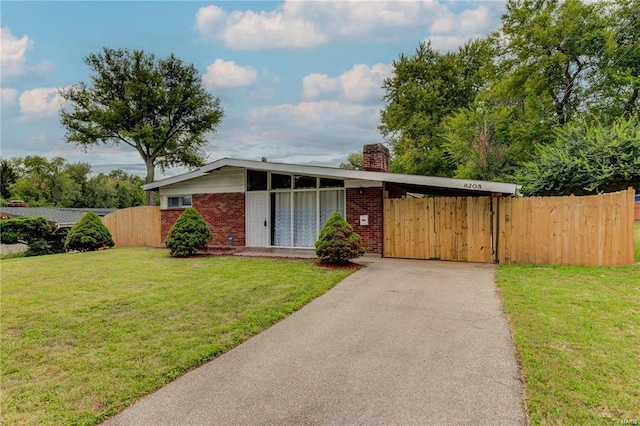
143,144,517,254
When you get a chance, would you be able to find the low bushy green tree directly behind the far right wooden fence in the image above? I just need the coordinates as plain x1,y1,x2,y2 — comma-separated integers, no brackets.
518,117,640,195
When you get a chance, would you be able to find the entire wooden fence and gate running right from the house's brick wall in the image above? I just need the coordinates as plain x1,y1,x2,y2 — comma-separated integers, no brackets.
384,189,634,265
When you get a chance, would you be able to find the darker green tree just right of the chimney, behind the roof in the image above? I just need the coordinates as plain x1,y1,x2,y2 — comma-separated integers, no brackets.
380,40,491,176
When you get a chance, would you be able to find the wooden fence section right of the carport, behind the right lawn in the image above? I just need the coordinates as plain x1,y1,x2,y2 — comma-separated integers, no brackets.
497,189,634,266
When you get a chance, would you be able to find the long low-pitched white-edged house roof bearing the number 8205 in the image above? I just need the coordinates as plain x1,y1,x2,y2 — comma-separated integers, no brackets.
142,158,518,195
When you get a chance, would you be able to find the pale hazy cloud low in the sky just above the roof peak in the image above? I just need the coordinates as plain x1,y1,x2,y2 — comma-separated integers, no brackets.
209,100,381,166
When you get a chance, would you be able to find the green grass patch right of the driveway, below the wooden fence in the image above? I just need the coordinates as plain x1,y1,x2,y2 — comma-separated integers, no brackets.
497,264,640,425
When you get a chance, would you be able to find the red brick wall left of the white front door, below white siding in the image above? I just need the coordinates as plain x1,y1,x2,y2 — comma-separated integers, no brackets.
162,192,245,246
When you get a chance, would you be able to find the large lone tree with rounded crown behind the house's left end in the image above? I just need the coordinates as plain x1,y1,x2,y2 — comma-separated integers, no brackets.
61,48,223,205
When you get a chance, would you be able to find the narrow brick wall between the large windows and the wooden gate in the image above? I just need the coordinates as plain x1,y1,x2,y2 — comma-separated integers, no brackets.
347,188,383,254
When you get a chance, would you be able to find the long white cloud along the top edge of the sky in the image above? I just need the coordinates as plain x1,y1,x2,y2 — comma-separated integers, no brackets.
196,0,504,49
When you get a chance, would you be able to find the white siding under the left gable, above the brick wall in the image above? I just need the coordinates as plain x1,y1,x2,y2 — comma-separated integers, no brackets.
160,167,246,198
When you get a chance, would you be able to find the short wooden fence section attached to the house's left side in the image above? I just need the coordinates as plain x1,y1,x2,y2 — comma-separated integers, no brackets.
102,206,162,247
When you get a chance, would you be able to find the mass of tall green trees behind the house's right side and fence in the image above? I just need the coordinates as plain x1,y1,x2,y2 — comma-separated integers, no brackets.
380,0,640,193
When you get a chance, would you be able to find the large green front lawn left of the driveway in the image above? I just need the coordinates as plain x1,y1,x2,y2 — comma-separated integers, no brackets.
0,248,352,425
